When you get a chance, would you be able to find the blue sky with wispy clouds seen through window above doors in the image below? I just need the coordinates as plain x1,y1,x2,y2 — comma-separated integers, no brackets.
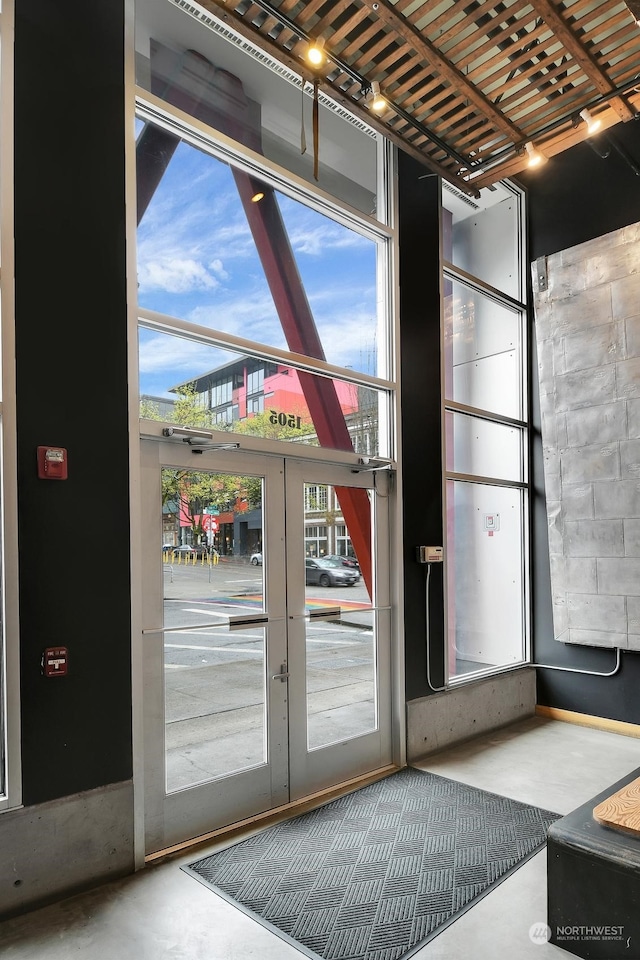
137,132,377,396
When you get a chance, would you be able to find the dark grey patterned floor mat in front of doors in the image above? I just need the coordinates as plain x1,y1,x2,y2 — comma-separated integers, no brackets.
182,767,560,960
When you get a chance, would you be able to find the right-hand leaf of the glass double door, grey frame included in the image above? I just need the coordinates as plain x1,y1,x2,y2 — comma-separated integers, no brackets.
285,461,391,800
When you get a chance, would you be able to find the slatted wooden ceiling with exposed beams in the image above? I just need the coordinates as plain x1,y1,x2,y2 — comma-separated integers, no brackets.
176,0,640,193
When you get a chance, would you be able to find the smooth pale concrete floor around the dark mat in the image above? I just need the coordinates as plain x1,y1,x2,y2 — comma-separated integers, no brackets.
0,717,640,960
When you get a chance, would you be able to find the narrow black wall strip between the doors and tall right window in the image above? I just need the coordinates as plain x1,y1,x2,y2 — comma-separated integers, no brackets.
398,153,444,700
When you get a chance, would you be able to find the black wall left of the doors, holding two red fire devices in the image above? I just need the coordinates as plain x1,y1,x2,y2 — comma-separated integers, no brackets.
15,0,132,805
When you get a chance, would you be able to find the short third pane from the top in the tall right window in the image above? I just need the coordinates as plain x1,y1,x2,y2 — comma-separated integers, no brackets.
445,411,524,483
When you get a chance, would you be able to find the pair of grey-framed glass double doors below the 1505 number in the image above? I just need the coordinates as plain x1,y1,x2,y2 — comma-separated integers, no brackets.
141,440,391,854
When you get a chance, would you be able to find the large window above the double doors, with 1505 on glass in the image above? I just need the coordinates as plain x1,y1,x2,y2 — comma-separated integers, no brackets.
136,0,395,457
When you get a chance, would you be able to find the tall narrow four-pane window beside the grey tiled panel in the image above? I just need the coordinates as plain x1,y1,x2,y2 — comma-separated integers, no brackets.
442,183,528,681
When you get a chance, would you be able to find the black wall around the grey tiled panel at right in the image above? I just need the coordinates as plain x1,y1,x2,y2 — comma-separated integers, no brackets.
520,121,640,723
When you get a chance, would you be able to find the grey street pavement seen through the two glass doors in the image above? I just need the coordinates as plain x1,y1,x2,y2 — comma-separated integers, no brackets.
154,560,376,789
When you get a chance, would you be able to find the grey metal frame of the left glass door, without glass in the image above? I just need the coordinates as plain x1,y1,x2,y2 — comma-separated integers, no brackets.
139,440,288,853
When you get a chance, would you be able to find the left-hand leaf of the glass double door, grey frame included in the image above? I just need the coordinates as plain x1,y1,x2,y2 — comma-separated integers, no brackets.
141,440,289,853
